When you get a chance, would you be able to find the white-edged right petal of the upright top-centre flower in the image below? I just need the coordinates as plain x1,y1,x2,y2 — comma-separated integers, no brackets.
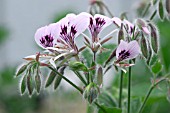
94,14,112,32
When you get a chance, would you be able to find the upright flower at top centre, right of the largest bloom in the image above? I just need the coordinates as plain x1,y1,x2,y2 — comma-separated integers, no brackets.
89,14,112,43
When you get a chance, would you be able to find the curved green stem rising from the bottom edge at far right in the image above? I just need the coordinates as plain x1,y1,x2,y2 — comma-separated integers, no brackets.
138,78,167,113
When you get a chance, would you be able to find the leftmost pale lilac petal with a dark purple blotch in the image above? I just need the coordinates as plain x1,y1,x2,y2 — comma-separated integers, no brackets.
35,26,54,48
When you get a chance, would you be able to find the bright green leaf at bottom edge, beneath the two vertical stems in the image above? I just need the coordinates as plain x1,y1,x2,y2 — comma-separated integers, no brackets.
98,105,122,113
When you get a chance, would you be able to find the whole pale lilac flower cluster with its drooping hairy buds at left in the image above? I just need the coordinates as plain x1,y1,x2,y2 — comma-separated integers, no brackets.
17,12,150,103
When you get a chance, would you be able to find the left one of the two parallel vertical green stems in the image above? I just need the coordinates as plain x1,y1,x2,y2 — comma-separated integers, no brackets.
119,70,123,108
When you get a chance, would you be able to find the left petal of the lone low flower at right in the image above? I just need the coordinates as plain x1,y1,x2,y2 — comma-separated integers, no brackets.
116,40,128,59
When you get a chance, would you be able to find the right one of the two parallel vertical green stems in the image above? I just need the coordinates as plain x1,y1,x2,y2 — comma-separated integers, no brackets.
127,60,132,113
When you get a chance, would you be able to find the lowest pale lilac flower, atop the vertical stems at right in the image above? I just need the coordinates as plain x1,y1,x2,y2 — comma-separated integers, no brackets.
115,40,141,63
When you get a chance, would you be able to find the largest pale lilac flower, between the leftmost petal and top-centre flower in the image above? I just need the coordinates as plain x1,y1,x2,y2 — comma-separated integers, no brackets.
48,12,89,53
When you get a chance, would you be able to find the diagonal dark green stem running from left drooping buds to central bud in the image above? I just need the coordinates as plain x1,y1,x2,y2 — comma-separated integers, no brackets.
48,66,83,94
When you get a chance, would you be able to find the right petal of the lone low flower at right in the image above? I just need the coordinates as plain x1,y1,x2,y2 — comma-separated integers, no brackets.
126,40,141,60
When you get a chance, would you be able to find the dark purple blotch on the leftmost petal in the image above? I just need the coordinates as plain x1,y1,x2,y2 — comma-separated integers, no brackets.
40,34,54,48
